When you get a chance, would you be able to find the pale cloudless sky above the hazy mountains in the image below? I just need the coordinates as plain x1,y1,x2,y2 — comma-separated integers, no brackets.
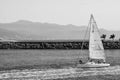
0,0,120,30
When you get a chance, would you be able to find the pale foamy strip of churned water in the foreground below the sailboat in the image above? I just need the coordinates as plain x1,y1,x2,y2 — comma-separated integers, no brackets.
0,66,120,80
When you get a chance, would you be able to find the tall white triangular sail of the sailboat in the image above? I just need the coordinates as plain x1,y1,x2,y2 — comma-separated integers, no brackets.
89,15,105,60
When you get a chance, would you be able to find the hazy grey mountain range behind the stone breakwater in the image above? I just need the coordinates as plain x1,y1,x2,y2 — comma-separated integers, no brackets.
0,20,120,40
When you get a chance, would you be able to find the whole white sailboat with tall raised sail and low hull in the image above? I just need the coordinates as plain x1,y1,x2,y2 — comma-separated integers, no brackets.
77,15,110,68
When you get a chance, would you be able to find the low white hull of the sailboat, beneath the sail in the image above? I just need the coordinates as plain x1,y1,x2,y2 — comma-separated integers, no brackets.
77,62,110,68
